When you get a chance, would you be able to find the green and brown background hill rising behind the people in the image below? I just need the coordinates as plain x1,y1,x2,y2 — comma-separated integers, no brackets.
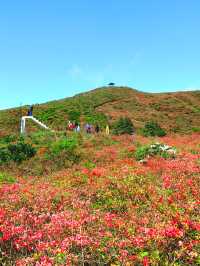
0,87,200,134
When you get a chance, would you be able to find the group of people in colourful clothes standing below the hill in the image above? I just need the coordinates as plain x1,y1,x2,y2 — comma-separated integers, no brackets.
67,121,109,135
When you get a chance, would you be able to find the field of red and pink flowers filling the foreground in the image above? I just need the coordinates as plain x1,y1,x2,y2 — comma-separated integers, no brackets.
0,134,200,266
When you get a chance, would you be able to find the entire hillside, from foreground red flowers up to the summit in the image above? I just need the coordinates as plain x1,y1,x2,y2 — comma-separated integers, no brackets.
0,88,200,266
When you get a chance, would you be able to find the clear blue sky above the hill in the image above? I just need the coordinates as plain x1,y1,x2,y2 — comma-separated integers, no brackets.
0,0,200,109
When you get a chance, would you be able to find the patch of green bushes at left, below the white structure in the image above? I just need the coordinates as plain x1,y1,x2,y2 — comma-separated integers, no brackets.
0,131,82,175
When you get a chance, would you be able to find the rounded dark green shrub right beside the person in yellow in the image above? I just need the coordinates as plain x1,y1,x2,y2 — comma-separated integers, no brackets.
113,117,134,135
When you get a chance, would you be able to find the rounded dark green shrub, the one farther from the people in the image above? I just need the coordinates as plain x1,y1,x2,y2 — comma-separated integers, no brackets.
142,121,166,137
